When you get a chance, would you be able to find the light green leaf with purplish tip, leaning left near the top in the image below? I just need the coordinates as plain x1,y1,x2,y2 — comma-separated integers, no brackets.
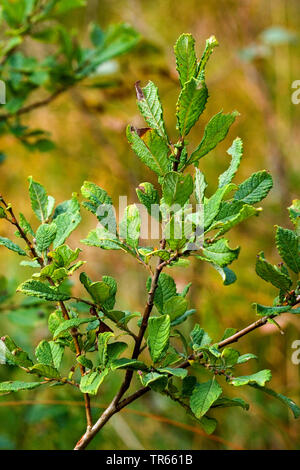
135,81,167,138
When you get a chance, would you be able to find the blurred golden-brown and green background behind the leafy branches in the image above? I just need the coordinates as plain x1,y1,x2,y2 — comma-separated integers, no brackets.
0,0,300,449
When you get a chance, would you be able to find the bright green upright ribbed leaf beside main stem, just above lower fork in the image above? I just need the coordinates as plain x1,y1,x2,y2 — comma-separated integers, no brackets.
148,315,171,363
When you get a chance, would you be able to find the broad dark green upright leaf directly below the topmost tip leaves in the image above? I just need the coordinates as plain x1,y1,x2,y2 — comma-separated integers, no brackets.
176,78,208,137
